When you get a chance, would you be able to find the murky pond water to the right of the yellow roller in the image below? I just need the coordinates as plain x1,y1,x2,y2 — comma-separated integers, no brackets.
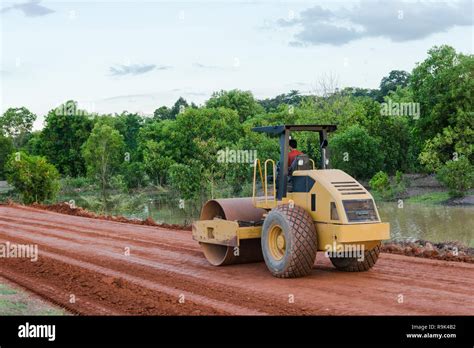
377,202,474,247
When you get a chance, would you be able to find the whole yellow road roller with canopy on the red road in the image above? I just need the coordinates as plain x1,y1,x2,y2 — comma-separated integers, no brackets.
192,125,390,278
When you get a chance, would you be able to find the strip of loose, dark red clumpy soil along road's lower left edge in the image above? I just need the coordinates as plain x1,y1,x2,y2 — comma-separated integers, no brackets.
0,250,226,315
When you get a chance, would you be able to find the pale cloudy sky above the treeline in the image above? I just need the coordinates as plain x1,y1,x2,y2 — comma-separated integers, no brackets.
0,0,474,128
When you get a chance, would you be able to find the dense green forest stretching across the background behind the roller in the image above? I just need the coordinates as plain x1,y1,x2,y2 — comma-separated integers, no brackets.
0,46,474,208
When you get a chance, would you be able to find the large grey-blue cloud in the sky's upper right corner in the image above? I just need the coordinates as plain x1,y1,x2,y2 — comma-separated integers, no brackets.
278,0,472,46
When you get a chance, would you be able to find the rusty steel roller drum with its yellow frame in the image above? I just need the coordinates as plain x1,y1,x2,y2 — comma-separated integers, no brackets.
193,198,266,266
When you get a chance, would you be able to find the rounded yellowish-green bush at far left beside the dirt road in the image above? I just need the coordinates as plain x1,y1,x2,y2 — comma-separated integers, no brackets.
5,152,59,204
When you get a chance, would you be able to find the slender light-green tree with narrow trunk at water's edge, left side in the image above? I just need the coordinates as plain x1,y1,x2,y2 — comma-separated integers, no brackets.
82,122,125,208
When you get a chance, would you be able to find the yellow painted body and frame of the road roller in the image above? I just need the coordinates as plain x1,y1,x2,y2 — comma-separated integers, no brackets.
193,169,390,251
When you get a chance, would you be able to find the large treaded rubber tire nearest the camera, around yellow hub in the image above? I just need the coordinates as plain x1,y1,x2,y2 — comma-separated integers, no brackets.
261,204,318,278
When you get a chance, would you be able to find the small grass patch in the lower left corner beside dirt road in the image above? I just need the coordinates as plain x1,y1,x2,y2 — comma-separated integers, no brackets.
0,284,66,316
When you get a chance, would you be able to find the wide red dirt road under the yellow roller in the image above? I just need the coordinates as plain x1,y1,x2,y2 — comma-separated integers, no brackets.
0,206,474,315
